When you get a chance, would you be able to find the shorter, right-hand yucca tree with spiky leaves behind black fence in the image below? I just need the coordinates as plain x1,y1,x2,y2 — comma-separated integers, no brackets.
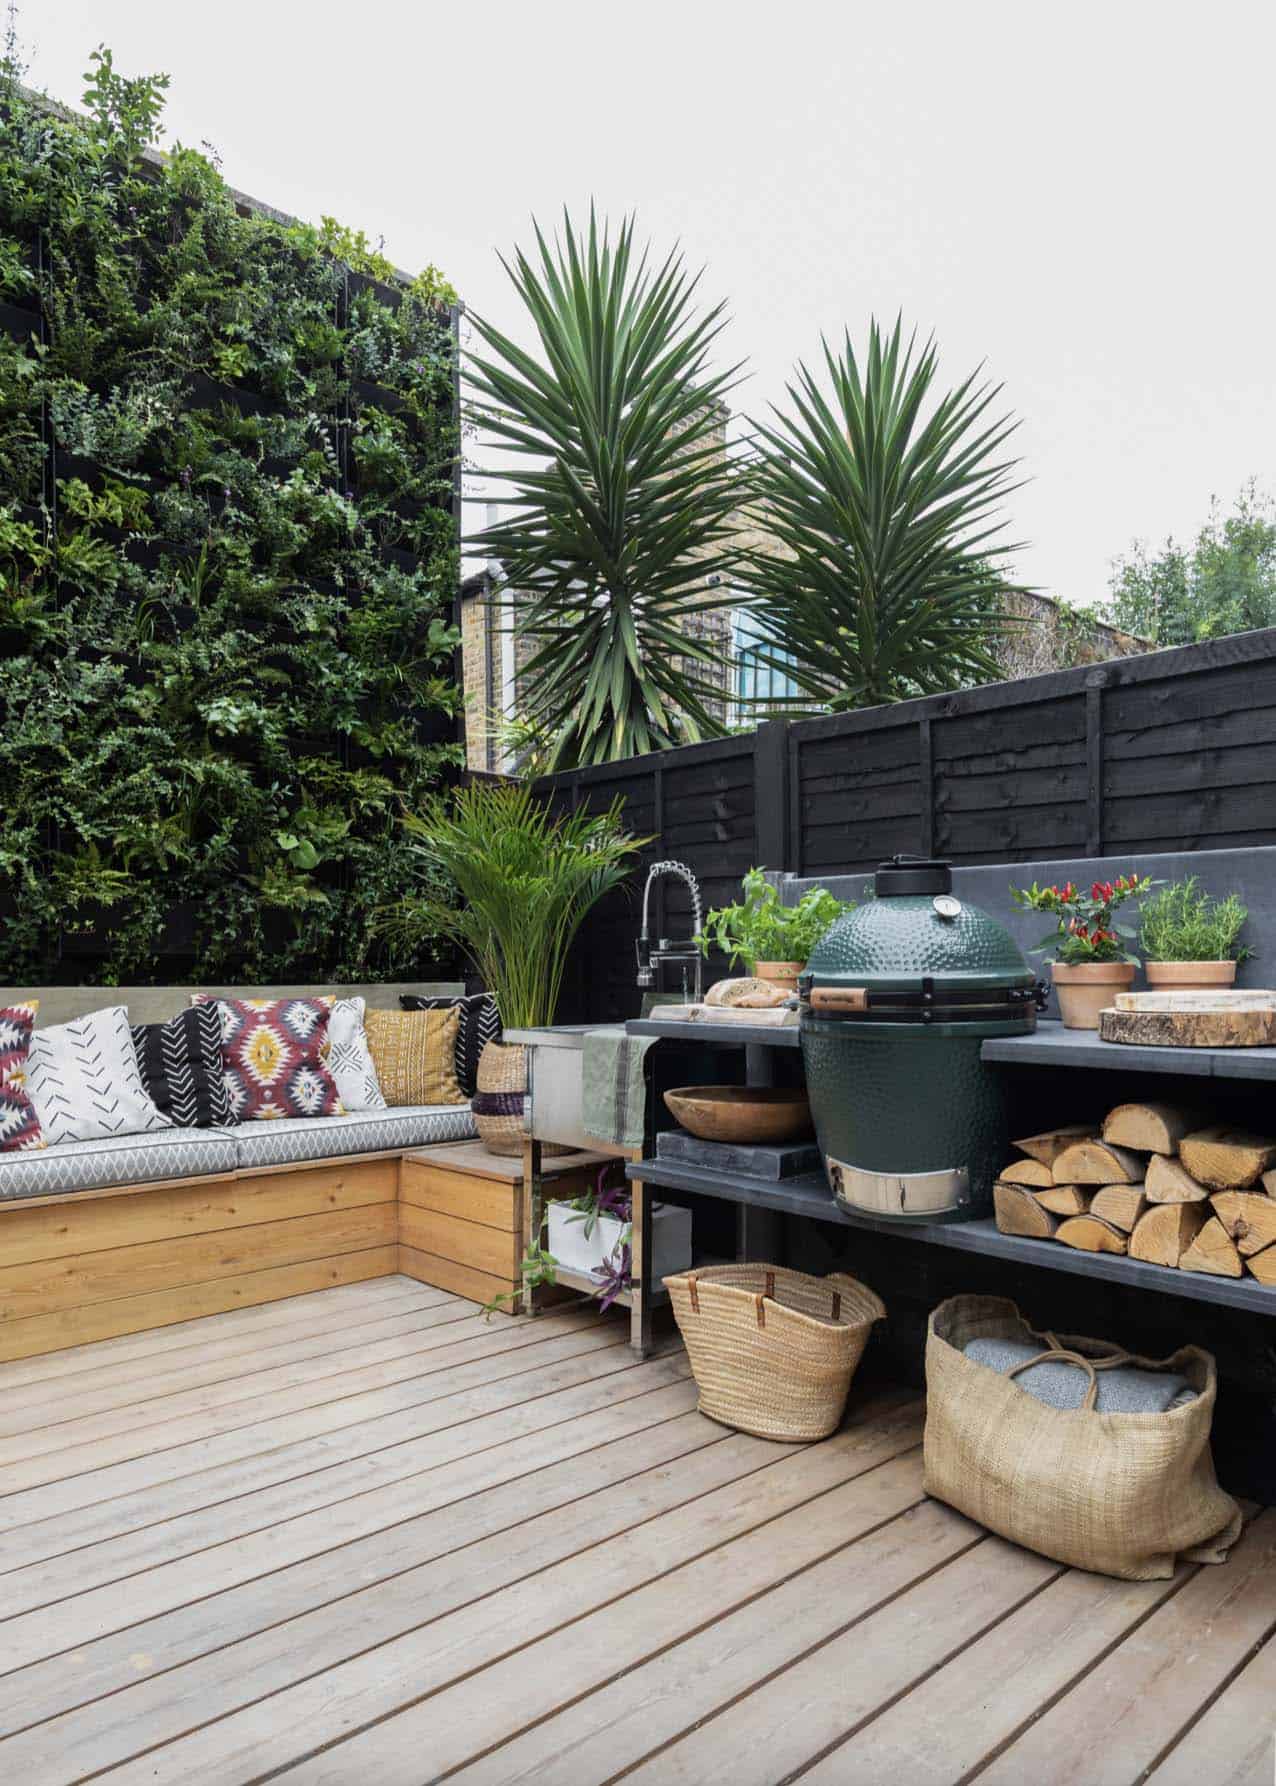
742,321,1017,711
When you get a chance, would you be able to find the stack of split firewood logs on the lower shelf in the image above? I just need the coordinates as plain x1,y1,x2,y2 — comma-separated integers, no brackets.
994,1104,1276,1284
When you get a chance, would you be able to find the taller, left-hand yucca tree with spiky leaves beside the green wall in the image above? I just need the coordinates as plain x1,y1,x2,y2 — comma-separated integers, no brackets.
468,209,738,770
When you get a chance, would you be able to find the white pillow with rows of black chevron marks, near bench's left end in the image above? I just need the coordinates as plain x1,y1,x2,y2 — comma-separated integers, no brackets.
27,1006,172,1145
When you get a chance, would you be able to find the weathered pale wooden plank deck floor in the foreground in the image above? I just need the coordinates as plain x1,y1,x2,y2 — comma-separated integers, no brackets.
0,1279,1276,1786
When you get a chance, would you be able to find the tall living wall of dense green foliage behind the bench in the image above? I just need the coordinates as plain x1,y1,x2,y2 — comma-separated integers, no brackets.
0,55,459,984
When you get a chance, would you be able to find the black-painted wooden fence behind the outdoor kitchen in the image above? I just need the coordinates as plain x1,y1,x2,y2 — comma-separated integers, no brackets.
540,629,1276,1022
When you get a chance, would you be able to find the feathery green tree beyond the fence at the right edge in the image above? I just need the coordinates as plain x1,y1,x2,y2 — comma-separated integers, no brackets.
1106,479,1276,645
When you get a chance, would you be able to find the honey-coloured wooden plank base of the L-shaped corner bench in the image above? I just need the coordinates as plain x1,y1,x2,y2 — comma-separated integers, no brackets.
0,1141,604,1359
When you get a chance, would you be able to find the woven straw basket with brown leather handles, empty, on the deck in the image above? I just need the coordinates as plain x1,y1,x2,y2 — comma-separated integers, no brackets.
665,1264,886,1440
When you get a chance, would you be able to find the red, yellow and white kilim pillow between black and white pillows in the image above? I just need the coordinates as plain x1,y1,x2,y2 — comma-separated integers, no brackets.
191,993,345,1122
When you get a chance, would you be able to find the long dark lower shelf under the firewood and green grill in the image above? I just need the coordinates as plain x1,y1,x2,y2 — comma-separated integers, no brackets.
625,1157,1276,1314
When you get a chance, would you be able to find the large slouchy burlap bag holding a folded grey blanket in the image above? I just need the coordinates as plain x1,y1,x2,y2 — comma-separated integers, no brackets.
924,1297,1240,1581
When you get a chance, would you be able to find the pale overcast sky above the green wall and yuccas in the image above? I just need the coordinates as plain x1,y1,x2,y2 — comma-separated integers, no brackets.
20,0,1276,602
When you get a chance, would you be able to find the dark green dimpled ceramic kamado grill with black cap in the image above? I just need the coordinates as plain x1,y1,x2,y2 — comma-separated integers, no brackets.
799,855,1044,1222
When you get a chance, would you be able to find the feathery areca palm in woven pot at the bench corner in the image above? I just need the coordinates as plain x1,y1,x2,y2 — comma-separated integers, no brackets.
384,782,647,1154
